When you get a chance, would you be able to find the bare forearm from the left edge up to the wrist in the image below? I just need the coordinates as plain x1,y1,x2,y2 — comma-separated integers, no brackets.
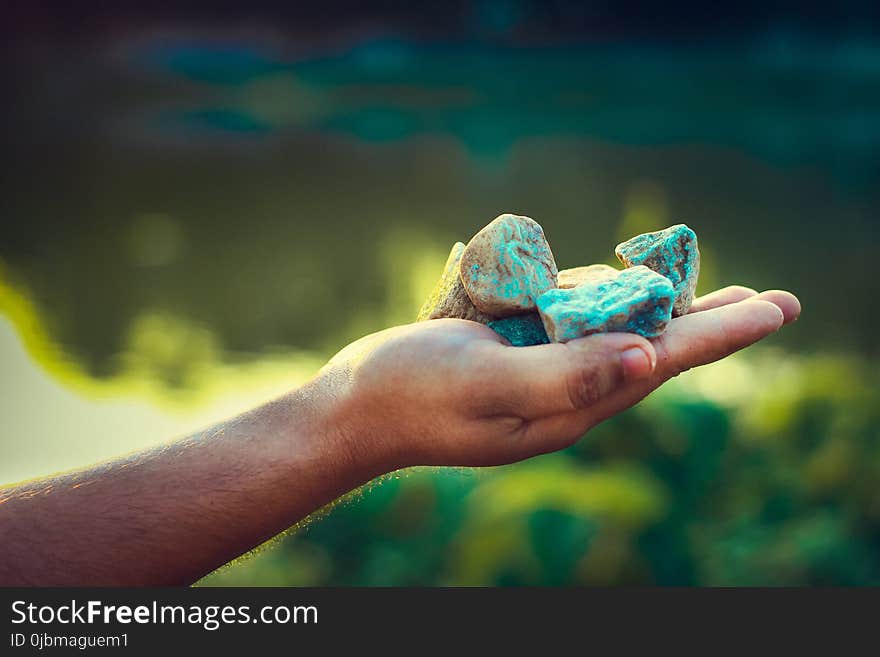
0,374,381,585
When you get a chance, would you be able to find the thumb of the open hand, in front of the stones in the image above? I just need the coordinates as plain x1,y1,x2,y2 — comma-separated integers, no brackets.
495,333,657,419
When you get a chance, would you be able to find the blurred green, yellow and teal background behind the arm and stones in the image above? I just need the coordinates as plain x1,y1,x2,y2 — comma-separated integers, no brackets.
0,0,880,585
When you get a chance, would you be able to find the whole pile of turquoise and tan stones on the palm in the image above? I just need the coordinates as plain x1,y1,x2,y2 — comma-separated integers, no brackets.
418,214,700,346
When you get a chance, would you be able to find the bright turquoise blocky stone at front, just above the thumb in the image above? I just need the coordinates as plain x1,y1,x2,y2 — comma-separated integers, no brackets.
538,266,675,342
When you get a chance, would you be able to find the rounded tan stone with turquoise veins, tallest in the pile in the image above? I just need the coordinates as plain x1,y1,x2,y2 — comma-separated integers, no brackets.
461,214,557,317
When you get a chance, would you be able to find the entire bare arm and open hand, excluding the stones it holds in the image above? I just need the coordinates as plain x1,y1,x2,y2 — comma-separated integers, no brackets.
0,286,800,586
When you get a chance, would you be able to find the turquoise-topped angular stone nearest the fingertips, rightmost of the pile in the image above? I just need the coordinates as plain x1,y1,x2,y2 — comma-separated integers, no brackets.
614,224,700,317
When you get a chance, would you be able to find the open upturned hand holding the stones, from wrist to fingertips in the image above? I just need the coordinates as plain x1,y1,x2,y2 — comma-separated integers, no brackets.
319,286,800,471
